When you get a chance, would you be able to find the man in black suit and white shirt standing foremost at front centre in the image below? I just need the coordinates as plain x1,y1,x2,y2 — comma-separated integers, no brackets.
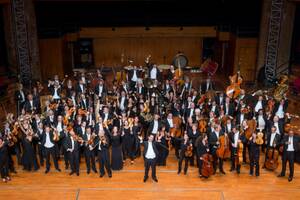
144,135,158,182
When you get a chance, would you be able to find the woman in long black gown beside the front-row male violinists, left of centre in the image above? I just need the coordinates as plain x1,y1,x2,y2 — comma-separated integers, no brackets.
111,126,123,170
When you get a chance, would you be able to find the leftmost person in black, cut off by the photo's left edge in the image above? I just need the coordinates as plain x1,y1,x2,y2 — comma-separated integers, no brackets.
0,137,11,183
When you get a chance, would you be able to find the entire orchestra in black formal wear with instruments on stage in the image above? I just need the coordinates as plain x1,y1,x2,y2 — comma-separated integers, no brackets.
0,60,299,182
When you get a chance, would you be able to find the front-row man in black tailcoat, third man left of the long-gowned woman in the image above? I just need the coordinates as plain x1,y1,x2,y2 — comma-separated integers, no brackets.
64,130,81,176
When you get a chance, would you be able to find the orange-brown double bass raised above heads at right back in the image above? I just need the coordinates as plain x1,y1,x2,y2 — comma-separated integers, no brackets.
226,71,243,99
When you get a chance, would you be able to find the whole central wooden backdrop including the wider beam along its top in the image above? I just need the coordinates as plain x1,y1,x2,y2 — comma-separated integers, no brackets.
79,27,216,67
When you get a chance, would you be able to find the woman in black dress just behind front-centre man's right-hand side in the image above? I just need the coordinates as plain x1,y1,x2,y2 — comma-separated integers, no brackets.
156,126,169,166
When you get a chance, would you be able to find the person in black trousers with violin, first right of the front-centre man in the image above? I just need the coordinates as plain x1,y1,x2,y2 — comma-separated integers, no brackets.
177,134,193,175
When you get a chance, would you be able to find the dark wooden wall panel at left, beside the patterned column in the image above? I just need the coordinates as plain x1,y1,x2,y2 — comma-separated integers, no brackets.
39,38,64,80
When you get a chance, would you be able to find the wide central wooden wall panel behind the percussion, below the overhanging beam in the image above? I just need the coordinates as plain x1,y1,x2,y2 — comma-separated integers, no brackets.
93,37,202,66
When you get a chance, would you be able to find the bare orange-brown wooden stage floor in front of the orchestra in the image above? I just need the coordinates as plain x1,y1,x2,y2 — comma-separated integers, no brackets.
0,152,300,200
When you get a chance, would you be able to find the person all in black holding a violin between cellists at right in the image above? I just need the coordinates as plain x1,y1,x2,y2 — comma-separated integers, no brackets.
248,132,260,176
